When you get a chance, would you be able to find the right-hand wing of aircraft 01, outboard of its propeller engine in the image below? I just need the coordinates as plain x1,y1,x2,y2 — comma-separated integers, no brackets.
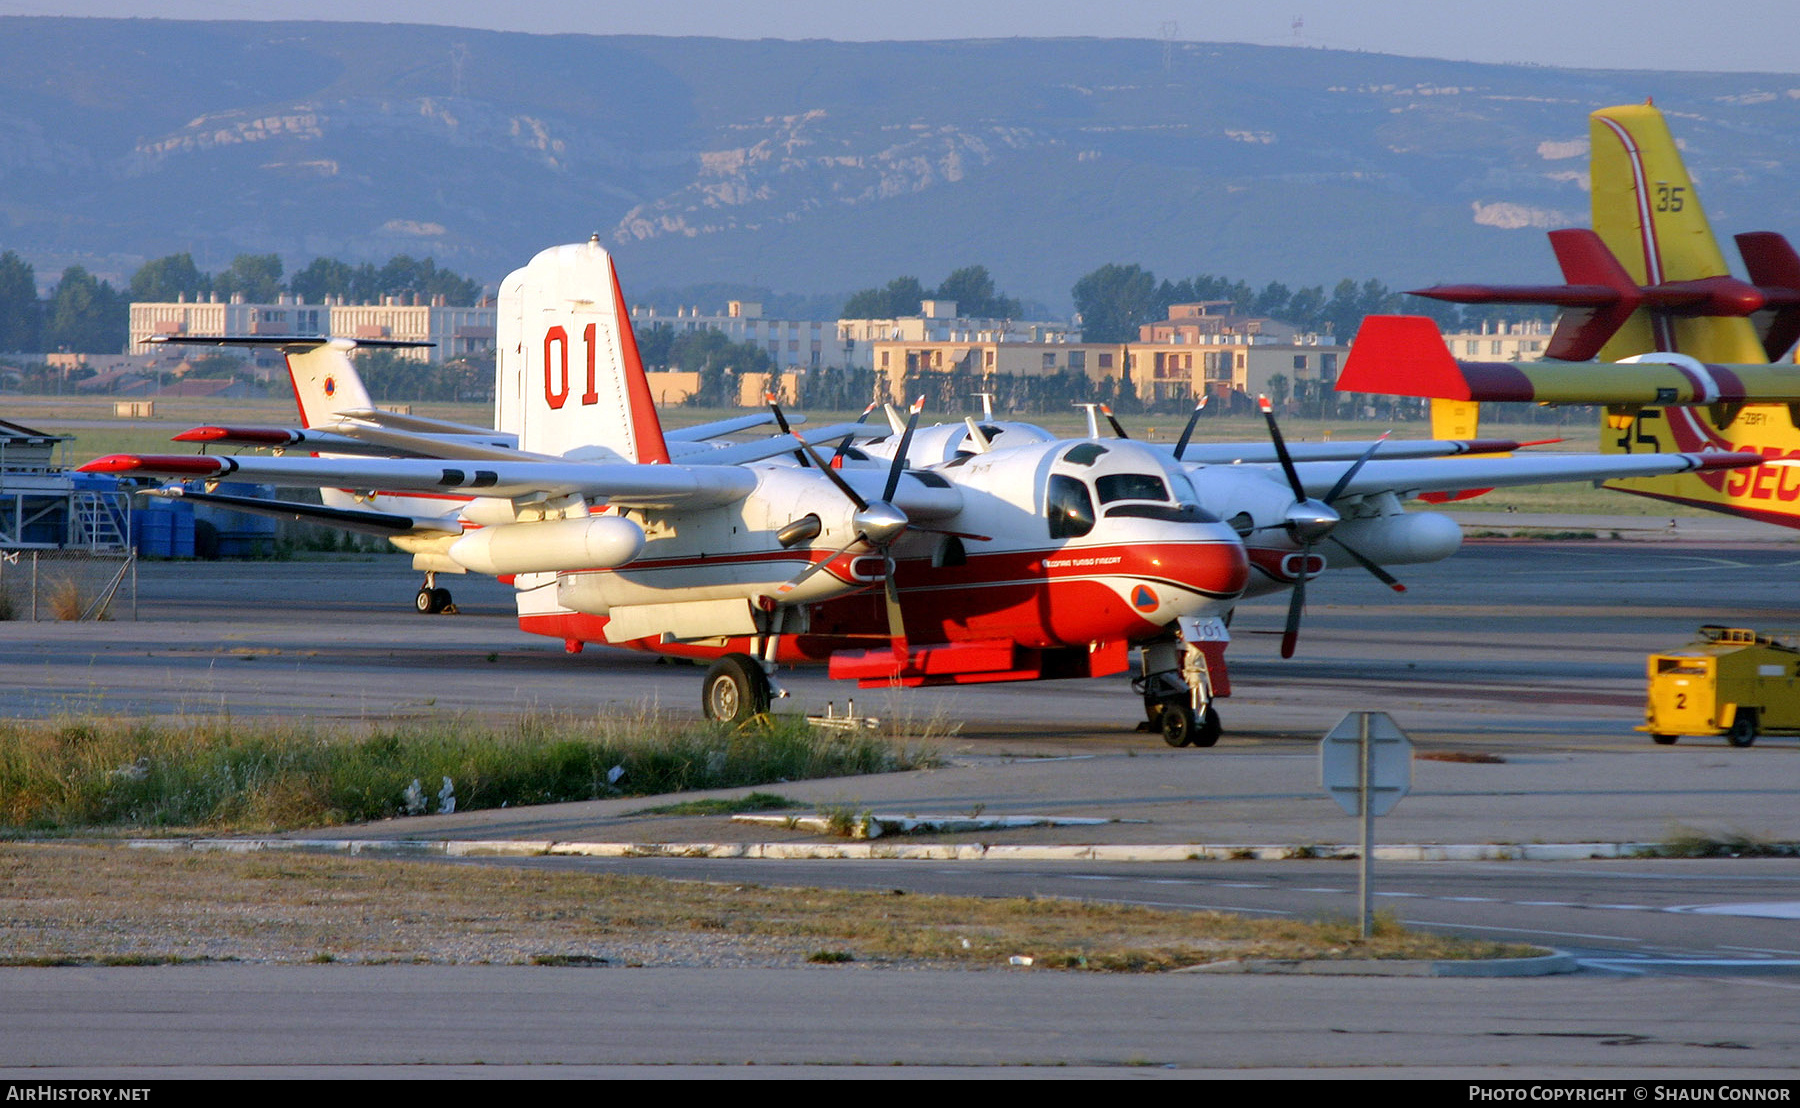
1294,453,1768,498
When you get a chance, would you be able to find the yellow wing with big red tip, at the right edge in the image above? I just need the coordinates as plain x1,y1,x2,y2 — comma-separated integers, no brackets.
1337,315,1800,405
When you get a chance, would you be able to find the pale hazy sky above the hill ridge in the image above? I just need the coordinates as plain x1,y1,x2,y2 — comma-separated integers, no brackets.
0,0,1800,74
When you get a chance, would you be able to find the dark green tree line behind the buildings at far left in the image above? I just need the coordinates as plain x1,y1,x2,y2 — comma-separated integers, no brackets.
0,250,481,354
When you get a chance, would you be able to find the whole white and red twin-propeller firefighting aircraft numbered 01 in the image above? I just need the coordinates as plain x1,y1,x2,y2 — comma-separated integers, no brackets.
85,241,1744,745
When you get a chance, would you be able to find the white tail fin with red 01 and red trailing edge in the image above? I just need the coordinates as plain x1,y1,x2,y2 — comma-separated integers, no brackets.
495,236,670,462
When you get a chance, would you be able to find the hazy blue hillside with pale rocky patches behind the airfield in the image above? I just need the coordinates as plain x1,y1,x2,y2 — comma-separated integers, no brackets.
0,18,1800,308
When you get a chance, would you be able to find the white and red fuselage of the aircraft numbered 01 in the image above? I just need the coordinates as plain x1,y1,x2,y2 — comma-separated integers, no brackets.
520,441,1249,660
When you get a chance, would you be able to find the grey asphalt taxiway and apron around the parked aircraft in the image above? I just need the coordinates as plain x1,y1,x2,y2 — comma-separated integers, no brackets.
10,541,1800,1076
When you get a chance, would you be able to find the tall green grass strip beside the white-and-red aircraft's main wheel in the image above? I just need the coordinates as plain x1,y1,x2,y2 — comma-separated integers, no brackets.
0,714,934,833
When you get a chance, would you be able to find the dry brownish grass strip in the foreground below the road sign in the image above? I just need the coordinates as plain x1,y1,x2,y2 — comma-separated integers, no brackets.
0,844,1535,973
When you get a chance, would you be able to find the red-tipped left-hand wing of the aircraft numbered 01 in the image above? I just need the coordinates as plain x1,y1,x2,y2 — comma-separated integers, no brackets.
81,453,756,507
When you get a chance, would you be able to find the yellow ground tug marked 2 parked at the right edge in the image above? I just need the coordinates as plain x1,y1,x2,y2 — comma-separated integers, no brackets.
1638,624,1800,746
